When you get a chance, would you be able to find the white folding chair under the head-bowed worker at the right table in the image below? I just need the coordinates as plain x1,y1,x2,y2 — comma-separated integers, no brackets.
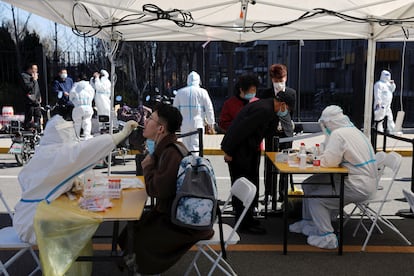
353,152,411,251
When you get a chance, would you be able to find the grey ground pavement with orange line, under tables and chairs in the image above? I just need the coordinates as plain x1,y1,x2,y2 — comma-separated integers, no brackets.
0,135,414,276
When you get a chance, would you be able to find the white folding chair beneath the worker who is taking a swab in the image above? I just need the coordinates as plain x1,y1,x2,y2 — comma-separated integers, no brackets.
0,190,40,276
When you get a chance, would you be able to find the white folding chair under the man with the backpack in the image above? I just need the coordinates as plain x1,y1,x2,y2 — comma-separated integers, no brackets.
185,177,256,275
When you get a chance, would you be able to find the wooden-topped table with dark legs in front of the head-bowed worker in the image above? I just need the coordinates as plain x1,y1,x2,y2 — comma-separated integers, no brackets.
266,152,349,255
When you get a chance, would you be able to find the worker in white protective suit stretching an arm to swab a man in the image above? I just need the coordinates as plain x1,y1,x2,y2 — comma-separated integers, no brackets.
13,115,138,244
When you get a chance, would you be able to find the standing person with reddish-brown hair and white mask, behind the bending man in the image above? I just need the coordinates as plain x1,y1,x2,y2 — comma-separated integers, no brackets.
259,64,296,204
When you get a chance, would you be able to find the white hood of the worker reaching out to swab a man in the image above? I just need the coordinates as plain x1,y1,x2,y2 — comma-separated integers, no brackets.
39,115,78,146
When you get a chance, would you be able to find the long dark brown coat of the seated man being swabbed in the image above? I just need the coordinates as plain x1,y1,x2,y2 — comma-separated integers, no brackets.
120,134,210,274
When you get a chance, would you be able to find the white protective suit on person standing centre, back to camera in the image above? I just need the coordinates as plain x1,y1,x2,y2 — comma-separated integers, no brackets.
173,71,215,154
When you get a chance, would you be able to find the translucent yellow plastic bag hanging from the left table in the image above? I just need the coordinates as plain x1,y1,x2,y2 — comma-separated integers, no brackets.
34,201,102,276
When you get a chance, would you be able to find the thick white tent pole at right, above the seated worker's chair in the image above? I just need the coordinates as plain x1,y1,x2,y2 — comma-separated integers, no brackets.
364,34,376,139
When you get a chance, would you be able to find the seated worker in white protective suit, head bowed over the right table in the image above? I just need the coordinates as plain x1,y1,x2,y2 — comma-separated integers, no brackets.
289,105,377,249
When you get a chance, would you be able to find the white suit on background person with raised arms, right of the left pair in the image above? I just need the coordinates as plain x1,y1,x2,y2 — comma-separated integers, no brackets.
90,69,111,116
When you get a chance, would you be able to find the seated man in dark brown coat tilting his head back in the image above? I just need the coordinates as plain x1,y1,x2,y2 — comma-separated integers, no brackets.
119,104,214,275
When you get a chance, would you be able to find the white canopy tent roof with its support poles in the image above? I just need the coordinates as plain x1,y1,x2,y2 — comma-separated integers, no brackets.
3,0,414,136
